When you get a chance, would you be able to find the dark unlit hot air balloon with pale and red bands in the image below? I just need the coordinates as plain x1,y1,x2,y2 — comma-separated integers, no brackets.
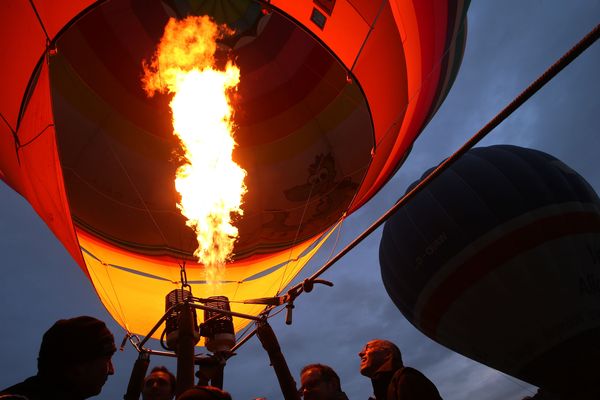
379,145,600,398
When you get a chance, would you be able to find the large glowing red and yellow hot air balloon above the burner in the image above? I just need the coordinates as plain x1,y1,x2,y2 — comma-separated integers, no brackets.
0,0,468,340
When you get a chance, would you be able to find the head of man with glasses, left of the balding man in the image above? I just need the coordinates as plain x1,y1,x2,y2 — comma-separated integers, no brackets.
298,364,348,400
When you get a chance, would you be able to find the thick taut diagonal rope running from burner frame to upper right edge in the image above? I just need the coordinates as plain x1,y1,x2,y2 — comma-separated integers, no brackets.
295,24,600,288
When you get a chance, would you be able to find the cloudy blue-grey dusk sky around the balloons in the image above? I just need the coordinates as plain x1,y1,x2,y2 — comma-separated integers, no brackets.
0,0,600,400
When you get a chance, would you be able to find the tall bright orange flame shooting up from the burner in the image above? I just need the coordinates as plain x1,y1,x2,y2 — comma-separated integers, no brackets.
142,16,246,284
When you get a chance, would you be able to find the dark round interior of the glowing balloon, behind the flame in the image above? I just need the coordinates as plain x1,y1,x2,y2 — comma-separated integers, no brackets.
50,1,374,260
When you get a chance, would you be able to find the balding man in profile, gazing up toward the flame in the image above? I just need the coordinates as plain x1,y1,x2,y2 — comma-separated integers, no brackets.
358,339,442,400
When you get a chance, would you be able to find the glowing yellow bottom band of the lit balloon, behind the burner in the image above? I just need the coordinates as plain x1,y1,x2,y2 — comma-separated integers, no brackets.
78,222,335,339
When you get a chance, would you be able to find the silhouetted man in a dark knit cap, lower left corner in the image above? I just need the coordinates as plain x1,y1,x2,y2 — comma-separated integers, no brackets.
0,316,116,400
